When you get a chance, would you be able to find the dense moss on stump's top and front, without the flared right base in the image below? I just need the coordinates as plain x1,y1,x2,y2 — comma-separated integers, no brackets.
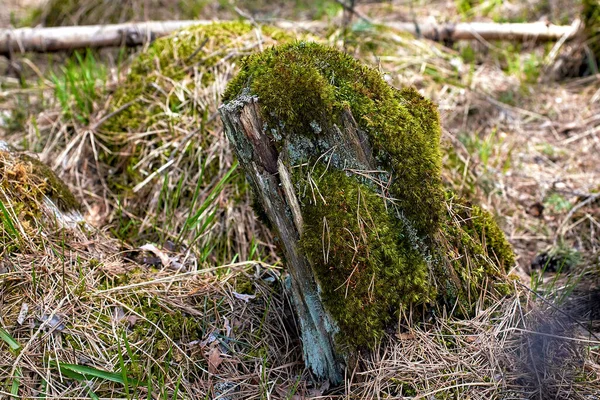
224,42,443,348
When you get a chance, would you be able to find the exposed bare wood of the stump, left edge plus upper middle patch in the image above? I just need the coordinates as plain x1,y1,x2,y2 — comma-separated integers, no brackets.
219,95,375,384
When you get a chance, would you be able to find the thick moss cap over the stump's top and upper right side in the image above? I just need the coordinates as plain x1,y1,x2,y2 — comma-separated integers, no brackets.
224,42,443,236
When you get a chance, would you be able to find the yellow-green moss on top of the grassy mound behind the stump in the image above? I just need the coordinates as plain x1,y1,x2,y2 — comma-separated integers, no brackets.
103,21,291,133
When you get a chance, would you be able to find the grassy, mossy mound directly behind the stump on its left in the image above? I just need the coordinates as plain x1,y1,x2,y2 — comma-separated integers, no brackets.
98,22,292,261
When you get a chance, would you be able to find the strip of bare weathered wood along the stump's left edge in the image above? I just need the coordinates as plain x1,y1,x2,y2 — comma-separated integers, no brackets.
219,96,343,384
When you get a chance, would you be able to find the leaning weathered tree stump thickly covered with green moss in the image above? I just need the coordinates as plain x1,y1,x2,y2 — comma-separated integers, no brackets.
220,42,514,383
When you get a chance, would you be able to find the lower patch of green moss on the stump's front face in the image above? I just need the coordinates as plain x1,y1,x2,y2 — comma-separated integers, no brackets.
299,165,432,347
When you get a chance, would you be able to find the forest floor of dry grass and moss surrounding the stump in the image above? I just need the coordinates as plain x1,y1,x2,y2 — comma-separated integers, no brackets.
0,0,600,399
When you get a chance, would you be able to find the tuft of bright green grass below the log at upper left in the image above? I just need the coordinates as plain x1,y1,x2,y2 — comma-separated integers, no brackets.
51,50,106,125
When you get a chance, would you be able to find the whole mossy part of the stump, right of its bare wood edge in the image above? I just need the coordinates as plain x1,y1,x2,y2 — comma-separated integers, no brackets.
225,42,514,347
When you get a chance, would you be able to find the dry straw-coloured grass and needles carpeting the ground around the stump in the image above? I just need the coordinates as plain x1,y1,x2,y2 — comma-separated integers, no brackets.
0,2,600,399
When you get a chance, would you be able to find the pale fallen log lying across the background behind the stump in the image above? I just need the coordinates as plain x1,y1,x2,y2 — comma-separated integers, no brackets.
0,20,581,56
